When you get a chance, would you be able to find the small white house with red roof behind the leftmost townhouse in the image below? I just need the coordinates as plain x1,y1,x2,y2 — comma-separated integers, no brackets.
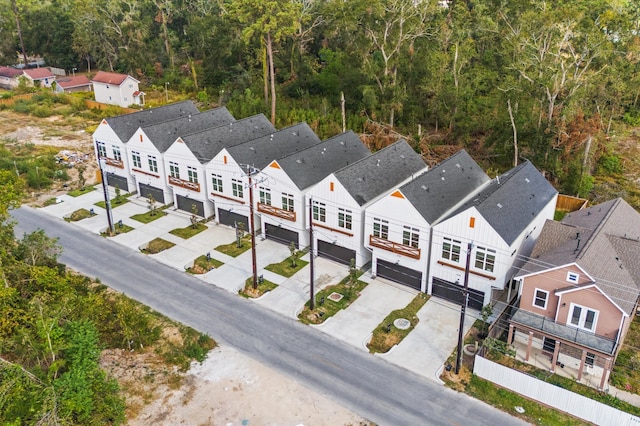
91,71,144,108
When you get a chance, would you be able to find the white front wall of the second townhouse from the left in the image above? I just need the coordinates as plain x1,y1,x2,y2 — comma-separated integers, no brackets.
126,128,173,203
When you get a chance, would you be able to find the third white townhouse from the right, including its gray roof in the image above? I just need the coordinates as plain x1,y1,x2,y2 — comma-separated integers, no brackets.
307,140,427,268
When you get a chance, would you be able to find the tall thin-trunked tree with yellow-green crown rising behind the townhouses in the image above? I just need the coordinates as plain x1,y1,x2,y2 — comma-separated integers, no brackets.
229,0,301,125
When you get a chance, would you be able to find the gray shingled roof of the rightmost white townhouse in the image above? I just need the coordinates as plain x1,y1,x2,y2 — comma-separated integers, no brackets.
448,161,558,245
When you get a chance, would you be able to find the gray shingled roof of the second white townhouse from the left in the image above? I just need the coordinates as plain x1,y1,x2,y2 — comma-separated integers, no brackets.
142,107,235,152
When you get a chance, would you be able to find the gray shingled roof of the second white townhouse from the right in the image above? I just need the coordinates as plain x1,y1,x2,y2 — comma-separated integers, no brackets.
400,150,491,224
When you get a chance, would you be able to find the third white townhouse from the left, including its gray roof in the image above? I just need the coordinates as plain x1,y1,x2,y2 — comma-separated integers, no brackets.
164,114,276,218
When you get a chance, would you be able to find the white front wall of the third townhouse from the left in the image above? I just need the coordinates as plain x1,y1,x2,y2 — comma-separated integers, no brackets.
162,138,214,217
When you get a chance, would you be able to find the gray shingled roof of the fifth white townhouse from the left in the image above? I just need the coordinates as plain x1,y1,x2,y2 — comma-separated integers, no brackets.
278,130,371,190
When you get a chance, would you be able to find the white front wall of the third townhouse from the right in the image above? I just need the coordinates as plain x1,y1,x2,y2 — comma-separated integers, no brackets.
307,174,371,268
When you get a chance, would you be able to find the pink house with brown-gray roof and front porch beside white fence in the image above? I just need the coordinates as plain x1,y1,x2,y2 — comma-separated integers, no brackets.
508,198,640,389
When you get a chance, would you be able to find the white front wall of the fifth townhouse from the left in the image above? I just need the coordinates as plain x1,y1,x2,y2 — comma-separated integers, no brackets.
253,162,309,248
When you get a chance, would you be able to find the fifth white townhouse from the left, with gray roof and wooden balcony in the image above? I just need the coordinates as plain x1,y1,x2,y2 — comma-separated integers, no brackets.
254,131,371,247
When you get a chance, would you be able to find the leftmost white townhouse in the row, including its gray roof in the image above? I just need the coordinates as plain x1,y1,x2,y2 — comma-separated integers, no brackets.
92,101,199,192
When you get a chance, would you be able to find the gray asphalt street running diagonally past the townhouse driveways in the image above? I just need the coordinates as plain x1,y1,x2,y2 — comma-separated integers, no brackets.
12,207,524,425
